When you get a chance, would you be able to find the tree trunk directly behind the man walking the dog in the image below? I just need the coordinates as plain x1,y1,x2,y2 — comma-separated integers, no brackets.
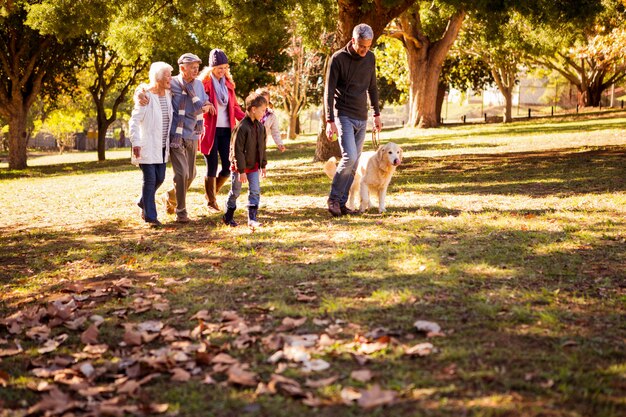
313,0,415,162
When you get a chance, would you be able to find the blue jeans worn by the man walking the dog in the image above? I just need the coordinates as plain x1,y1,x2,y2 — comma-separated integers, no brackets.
328,116,367,206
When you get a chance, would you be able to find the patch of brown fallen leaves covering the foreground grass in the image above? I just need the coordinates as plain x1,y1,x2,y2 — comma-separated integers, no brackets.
0,278,443,416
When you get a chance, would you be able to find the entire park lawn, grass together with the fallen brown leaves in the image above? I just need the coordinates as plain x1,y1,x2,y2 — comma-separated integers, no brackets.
0,113,626,417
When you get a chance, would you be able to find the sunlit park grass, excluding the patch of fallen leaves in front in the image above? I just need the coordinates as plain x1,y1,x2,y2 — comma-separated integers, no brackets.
0,115,626,417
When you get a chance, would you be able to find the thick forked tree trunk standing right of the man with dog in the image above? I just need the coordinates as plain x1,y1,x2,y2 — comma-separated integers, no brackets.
394,6,465,128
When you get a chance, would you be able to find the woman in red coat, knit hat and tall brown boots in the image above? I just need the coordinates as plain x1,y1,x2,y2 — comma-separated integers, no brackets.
198,49,246,212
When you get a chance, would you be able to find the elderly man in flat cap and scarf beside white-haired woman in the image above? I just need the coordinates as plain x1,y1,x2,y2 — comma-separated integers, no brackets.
138,53,215,223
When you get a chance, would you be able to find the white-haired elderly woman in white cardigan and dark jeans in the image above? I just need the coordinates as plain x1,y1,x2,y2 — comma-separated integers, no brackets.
128,62,173,227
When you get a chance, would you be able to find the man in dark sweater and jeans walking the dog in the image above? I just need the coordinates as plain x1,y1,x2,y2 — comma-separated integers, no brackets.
324,23,382,216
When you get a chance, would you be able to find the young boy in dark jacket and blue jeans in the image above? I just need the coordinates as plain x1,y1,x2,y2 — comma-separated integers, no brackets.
222,93,267,229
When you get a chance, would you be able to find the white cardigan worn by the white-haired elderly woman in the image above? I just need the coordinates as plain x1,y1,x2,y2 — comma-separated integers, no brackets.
128,90,172,164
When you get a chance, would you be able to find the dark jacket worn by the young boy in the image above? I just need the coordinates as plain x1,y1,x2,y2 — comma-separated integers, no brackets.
229,116,267,174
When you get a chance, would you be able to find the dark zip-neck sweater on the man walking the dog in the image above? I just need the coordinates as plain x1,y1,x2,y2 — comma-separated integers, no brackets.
324,43,380,121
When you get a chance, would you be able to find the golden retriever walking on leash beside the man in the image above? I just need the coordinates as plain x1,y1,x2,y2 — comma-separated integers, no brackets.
324,142,402,213
